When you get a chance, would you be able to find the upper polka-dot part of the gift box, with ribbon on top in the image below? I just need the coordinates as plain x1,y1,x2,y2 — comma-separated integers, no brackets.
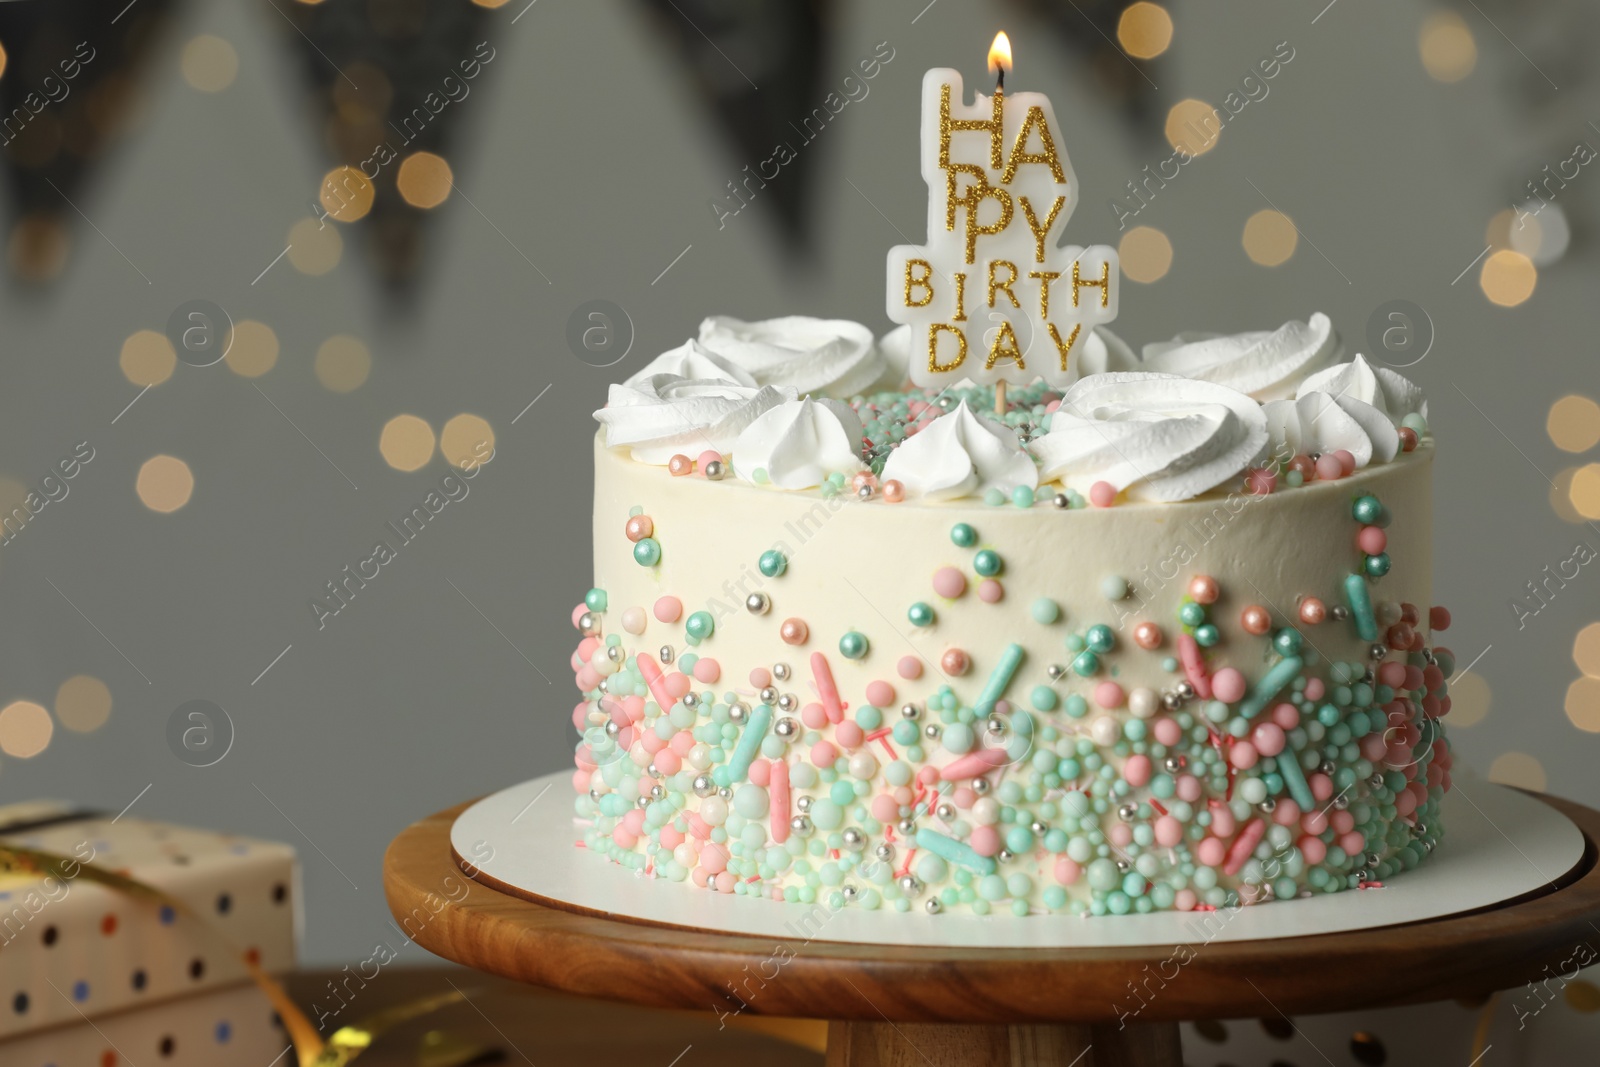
0,803,299,1036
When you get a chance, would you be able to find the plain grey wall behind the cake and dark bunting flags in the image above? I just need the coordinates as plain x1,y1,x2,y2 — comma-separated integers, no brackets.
0,0,1600,979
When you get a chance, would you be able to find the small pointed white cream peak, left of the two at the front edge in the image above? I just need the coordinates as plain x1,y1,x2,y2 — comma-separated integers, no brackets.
733,397,864,490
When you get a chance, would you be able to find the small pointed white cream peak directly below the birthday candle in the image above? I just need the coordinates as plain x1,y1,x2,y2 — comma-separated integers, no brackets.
883,400,1038,499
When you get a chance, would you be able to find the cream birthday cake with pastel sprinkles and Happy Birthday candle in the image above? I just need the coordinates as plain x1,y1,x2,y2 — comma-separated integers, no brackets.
571,49,1454,917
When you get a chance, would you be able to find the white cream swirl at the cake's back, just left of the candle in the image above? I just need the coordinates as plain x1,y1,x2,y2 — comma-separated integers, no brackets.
699,315,888,400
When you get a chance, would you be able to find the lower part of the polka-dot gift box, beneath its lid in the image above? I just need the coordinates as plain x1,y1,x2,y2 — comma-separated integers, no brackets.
0,985,294,1067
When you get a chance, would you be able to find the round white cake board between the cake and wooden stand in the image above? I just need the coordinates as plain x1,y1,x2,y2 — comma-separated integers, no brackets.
450,773,1584,949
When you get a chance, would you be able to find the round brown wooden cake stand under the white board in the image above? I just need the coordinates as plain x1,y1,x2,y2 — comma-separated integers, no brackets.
384,797,1600,1067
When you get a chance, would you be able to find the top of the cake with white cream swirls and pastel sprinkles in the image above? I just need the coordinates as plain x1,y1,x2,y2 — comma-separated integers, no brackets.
595,314,1427,507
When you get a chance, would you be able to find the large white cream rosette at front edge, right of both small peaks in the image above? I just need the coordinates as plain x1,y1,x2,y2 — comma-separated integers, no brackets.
1029,371,1267,501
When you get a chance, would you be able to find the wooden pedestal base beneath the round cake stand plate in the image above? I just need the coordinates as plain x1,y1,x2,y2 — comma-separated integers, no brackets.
827,1022,1182,1067
